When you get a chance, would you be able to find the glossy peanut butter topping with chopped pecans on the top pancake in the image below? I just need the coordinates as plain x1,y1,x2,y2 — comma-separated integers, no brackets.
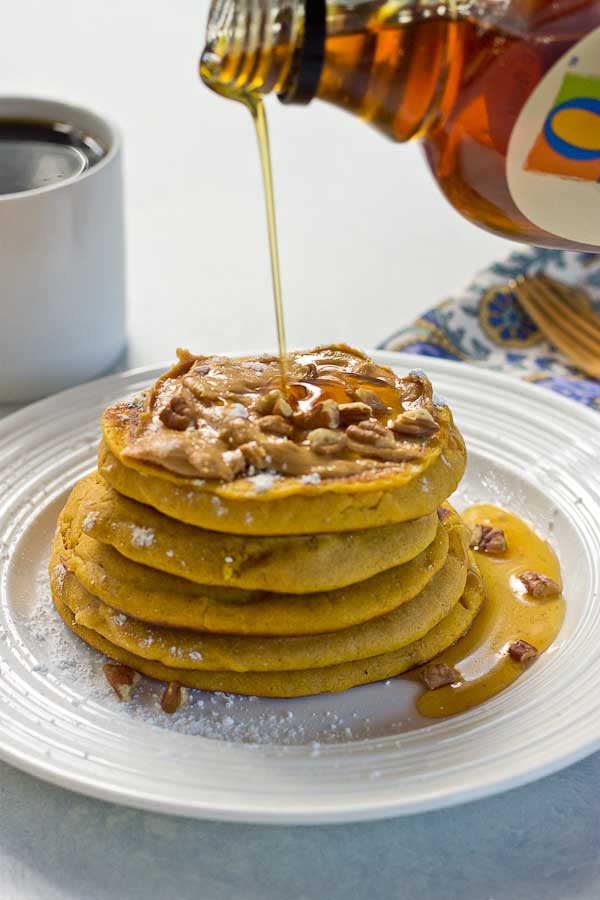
123,345,442,481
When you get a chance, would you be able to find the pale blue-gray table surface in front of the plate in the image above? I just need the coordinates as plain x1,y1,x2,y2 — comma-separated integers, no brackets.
0,754,600,900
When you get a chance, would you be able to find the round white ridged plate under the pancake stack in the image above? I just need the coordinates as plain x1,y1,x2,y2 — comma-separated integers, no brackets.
0,353,600,823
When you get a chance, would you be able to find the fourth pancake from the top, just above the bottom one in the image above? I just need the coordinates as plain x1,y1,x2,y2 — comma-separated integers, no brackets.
51,526,467,672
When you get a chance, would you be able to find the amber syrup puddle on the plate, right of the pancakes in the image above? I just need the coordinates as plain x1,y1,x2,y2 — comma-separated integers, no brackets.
417,504,564,718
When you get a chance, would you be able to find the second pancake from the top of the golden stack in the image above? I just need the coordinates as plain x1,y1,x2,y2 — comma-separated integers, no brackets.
68,473,438,594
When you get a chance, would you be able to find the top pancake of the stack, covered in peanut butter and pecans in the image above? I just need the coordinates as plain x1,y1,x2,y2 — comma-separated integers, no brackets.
99,345,466,535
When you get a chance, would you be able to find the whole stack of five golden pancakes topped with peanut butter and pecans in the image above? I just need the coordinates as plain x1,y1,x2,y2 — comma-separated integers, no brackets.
50,346,483,697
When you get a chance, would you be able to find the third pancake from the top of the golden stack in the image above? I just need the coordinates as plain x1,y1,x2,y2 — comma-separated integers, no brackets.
50,500,458,635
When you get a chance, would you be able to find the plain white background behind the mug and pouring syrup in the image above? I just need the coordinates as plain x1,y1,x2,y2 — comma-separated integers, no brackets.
0,0,512,364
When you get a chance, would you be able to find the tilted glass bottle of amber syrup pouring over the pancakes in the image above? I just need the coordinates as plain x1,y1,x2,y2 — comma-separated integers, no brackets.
201,0,600,250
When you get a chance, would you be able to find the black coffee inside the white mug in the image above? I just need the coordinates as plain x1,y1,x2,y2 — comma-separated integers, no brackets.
0,119,106,194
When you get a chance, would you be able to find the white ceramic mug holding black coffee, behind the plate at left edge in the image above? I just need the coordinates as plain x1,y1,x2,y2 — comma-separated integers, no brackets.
0,97,126,403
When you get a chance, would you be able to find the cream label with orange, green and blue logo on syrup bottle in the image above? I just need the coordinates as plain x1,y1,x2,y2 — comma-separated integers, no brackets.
506,28,600,246
